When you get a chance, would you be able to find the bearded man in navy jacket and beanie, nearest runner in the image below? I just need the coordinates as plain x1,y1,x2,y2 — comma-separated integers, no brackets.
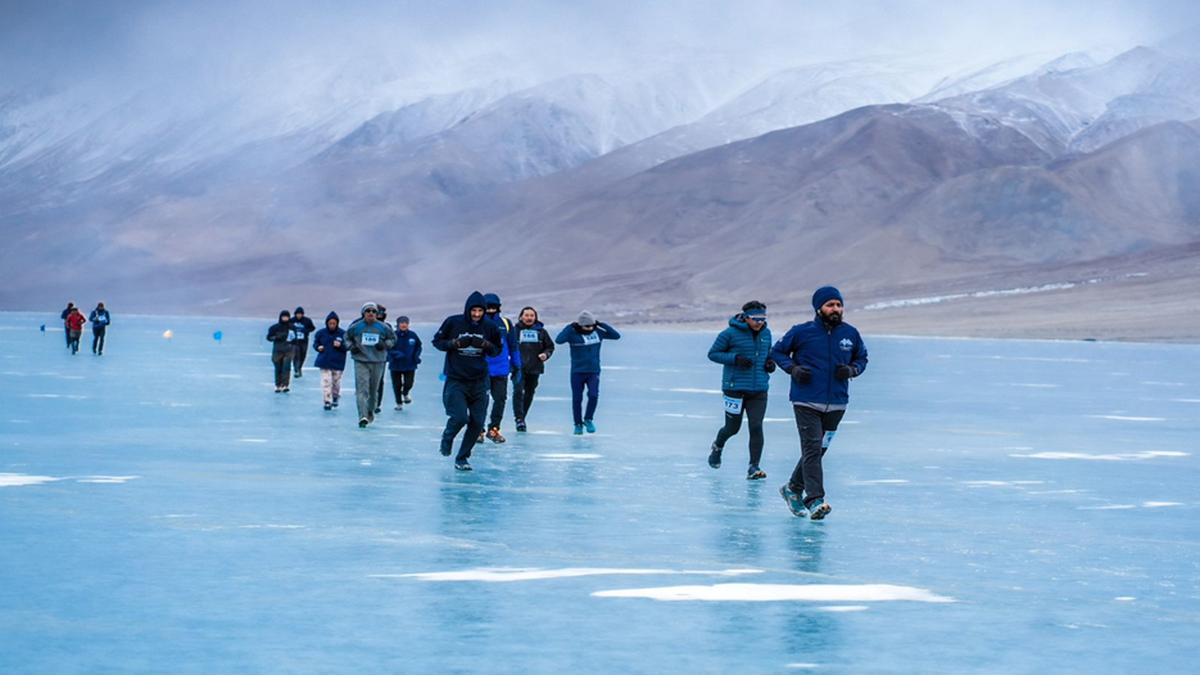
770,286,866,520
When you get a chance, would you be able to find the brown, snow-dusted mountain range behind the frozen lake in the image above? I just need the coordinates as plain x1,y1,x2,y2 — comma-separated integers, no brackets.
0,2,1200,339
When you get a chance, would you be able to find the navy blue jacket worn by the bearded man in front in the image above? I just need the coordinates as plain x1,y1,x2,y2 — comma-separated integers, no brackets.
770,319,866,407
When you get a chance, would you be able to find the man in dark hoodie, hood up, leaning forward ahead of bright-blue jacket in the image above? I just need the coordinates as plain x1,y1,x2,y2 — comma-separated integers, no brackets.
433,291,503,471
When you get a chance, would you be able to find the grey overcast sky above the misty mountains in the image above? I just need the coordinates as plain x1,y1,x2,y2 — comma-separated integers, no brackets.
0,0,1200,96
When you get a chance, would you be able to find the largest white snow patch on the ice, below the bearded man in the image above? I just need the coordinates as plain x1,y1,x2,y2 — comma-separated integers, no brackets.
592,584,956,603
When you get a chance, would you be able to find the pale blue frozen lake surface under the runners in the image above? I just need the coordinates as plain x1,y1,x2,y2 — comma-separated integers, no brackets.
0,312,1200,673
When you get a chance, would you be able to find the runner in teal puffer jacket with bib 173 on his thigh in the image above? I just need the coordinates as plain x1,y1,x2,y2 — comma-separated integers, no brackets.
708,300,775,480
